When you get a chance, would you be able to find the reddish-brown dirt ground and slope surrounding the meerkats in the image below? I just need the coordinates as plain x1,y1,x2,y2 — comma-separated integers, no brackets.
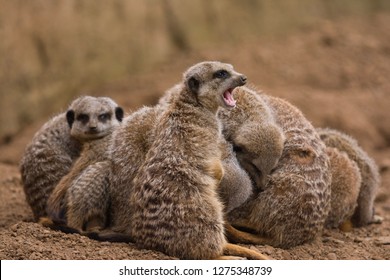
0,14,390,260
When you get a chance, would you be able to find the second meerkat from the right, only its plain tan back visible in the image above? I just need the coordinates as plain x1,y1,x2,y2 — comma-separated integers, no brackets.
325,147,362,231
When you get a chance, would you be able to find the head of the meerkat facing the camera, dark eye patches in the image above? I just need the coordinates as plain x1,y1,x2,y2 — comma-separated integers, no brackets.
66,96,123,141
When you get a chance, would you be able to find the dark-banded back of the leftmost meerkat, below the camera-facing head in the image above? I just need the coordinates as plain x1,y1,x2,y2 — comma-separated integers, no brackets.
20,113,81,220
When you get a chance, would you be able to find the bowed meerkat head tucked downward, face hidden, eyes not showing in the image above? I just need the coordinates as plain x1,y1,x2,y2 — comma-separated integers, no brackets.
232,123,285,188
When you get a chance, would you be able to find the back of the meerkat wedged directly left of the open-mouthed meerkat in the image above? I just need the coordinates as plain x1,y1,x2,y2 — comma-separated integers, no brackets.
109,105,162,233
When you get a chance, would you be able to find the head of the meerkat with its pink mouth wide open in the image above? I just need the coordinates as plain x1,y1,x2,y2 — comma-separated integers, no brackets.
183,61,246,110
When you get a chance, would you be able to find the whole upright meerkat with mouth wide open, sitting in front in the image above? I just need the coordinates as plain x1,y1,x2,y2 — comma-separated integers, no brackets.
125,62,265,259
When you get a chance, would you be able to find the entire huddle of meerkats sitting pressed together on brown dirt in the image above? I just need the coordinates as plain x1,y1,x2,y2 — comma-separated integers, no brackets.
21,62,379,259
